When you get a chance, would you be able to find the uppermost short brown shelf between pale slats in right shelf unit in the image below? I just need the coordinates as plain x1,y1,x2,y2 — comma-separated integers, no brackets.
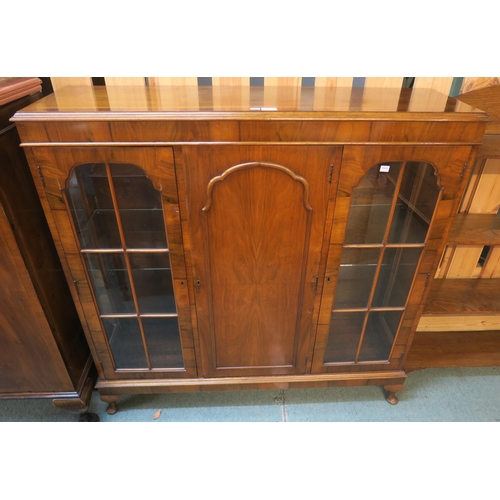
447,214,500,245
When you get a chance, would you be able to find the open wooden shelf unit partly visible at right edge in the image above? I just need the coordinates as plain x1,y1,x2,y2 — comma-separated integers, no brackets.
405,82,500,371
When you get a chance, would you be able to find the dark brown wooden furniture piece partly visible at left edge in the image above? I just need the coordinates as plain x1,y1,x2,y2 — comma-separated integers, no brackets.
0,78,95,413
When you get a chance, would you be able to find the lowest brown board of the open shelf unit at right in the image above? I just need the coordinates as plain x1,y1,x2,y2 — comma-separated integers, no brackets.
404,330,500,373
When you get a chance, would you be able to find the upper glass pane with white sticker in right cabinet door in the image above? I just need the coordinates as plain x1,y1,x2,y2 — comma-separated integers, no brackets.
345,162,402,245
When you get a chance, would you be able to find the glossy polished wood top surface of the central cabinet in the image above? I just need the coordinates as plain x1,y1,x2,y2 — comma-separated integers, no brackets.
13,86,488,121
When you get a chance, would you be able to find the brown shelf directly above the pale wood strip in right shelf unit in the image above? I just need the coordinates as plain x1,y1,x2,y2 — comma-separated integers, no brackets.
423,278,500,315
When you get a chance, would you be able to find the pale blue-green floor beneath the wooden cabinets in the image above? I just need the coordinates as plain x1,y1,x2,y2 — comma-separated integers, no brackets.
0,367,500,422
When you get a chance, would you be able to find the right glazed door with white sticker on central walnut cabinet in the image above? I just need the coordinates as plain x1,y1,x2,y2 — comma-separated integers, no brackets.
313,146,471,373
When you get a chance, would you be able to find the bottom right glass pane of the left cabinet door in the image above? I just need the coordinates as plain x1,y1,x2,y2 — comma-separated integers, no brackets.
142,318,184,368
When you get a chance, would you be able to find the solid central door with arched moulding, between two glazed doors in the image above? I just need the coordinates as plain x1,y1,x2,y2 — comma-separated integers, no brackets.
178,146,335,376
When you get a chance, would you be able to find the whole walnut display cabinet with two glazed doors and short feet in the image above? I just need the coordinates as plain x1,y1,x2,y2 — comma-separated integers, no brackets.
13,86,488,413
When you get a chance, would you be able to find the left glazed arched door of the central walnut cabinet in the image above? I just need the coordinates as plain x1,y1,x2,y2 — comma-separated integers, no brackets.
28,148,197,379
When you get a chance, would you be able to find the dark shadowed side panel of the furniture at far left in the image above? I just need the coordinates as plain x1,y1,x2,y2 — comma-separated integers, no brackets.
0,128,90,386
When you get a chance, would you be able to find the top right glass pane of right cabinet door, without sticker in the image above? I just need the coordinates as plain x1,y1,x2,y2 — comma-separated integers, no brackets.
388,162,439,243
